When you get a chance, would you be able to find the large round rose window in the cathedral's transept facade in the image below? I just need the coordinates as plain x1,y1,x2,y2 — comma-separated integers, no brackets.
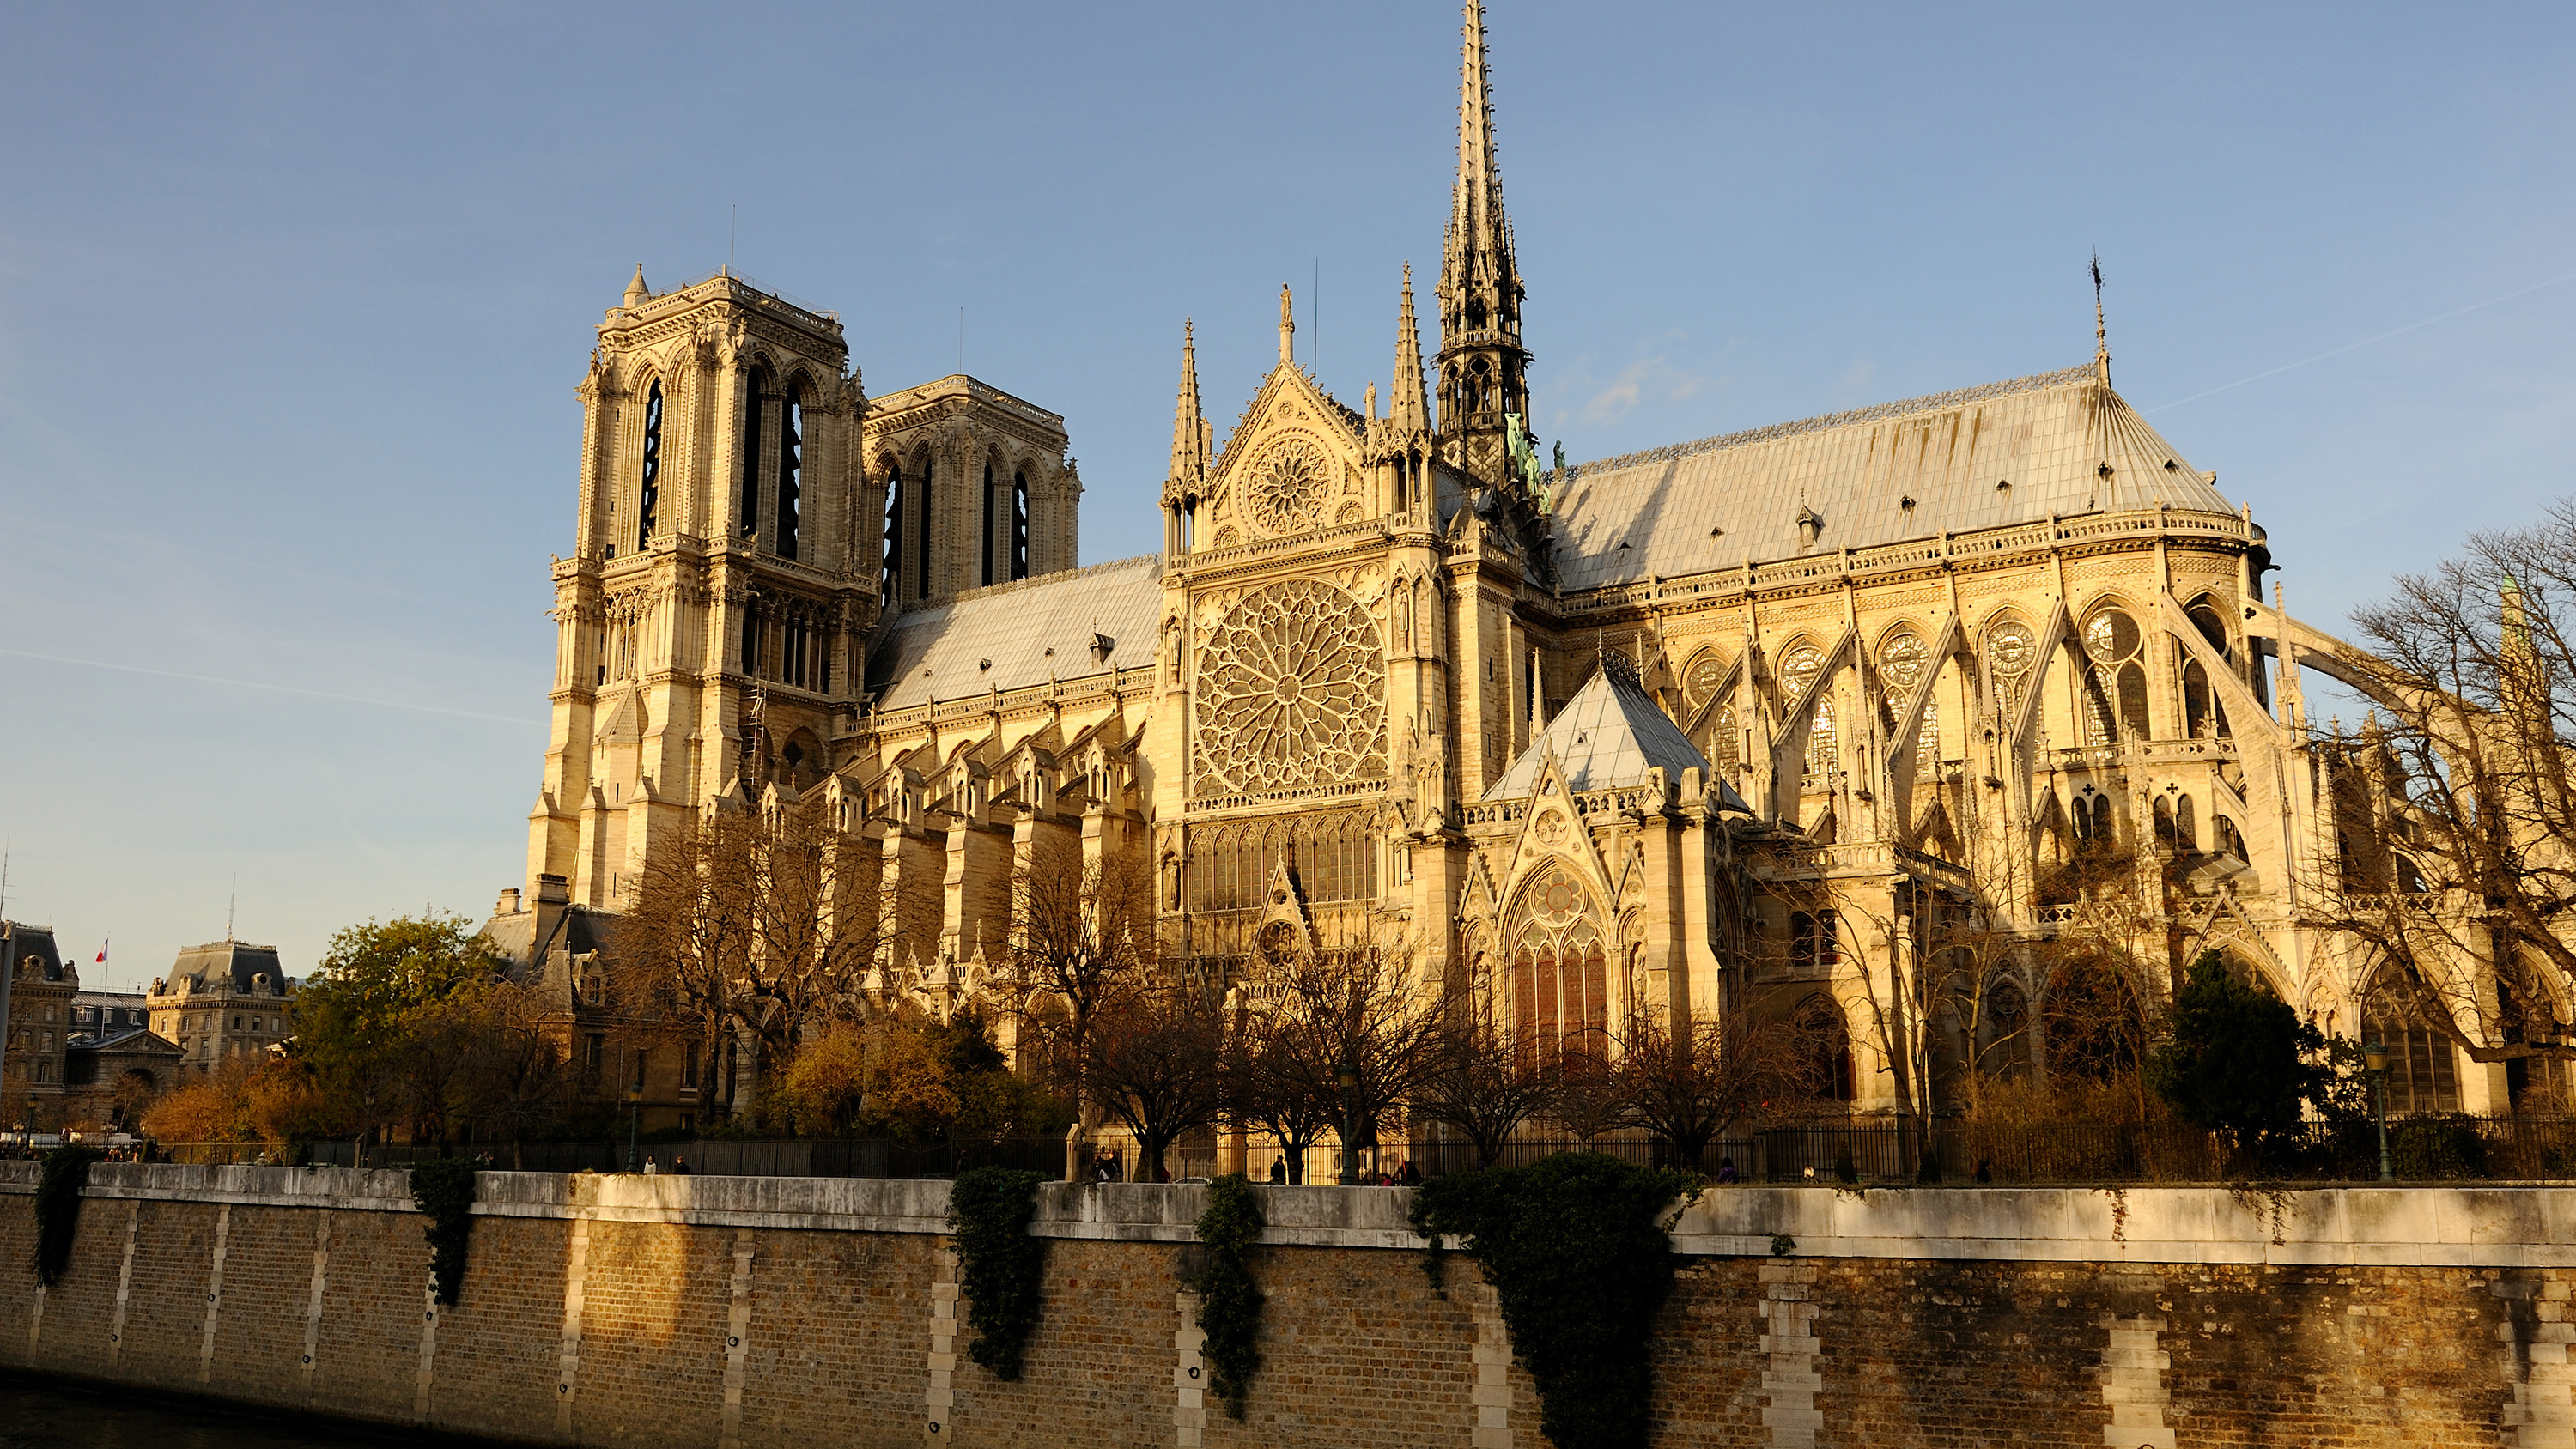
1193,579,1386,795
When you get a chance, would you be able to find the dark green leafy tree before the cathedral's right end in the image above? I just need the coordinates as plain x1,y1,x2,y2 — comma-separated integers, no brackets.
2146,952,2329,1166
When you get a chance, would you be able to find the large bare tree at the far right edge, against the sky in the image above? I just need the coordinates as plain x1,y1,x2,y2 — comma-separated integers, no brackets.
2300,500,2576,1076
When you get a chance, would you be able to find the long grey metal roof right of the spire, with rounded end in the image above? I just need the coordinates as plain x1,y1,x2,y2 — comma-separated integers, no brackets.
1556,366,2236,590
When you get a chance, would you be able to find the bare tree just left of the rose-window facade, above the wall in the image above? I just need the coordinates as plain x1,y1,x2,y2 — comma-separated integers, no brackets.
999,834,1154,1179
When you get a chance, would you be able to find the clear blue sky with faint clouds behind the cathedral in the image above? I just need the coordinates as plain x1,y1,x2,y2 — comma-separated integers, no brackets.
0,0,2576,985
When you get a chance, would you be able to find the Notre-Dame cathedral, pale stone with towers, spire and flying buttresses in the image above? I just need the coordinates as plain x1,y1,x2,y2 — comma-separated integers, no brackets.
492,0,2504,1112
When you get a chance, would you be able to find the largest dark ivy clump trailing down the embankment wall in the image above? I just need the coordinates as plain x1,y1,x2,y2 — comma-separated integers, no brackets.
1412,1153,1703,1449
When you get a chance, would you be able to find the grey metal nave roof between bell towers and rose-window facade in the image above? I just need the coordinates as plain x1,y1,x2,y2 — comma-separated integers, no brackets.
868,554,1162,711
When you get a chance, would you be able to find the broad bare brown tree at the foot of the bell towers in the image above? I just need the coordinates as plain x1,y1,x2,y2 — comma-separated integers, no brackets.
616,795,889,1112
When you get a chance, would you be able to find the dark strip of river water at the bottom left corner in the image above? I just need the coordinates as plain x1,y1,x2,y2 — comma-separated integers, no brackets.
0,1374,497,1449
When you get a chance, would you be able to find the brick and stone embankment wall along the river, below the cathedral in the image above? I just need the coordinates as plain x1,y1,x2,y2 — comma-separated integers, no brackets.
0,1163,2576,1449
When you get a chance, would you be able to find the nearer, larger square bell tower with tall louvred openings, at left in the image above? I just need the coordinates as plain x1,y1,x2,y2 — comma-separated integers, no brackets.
528,268,878,908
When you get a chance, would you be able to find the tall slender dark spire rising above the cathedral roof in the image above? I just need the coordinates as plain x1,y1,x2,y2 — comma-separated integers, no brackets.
1432,0,1530,487
